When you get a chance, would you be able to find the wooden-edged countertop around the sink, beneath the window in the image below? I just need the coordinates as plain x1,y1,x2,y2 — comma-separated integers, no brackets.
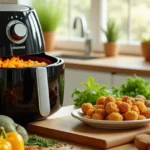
47,50,150,76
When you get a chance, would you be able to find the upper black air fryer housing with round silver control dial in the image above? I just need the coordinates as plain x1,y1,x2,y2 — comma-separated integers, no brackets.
0,4,45,57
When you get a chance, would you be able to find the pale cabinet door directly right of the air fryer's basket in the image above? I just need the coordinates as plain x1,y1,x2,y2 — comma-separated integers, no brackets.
63,68,111,106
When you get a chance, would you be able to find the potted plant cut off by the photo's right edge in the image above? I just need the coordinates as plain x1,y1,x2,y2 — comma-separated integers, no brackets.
141,36,150,61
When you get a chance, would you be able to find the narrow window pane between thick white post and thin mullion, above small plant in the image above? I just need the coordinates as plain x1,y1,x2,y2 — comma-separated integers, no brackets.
107,0,128,41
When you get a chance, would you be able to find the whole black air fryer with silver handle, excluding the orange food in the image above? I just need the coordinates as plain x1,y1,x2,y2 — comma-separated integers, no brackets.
0,4,64,124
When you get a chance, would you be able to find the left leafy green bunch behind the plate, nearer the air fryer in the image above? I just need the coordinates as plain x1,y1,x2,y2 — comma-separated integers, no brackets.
72,77,110,107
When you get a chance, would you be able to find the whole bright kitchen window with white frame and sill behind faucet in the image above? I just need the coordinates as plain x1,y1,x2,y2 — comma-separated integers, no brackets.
19,0,150,54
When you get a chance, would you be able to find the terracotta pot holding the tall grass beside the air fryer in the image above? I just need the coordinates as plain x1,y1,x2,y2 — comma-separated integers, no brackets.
43,31,56,52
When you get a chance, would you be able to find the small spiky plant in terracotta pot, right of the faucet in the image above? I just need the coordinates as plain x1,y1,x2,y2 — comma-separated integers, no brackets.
102,19,119,56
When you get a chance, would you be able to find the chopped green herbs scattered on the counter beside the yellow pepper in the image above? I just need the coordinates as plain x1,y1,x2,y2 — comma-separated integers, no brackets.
27,135,58,147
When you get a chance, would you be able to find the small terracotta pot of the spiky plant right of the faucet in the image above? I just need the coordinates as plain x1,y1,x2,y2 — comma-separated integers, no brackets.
104,43,119,56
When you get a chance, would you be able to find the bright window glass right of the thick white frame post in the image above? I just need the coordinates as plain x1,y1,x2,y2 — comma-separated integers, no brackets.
108,0,150,42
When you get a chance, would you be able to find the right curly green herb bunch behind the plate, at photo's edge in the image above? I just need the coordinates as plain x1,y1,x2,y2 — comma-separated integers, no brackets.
112,75,150,99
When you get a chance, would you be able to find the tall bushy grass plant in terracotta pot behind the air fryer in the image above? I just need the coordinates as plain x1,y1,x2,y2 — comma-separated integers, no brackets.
32,0,63,51
